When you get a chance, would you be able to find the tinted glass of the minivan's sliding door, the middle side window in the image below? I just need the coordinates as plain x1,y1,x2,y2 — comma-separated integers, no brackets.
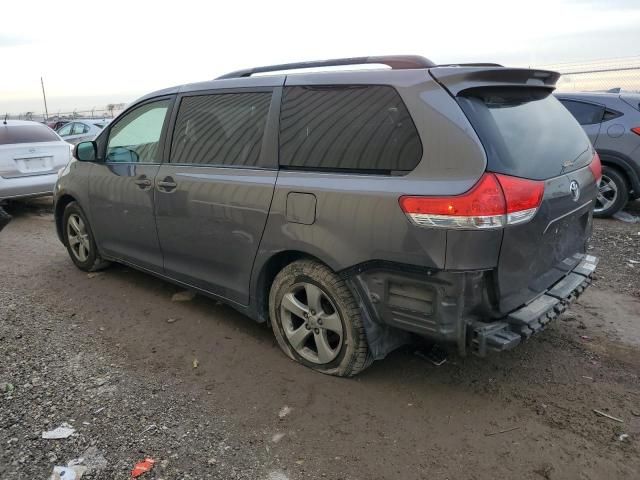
171,93,271,166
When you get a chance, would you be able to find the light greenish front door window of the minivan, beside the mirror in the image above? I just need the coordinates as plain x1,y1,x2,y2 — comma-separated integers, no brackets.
106,100,170,163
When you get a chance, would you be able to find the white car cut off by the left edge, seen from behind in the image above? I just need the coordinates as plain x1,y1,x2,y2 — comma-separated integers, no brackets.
0,120,72,201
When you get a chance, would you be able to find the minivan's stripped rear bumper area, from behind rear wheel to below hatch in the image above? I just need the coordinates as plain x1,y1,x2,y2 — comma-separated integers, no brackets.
343,254,598,360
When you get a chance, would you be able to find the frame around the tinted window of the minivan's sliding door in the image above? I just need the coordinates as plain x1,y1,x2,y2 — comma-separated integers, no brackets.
163,86,282,170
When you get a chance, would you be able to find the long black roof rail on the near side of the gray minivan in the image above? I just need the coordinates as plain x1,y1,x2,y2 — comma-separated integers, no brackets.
216,55,435,80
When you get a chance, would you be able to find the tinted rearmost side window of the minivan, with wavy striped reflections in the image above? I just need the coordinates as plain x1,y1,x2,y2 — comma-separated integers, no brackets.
280,86,422,173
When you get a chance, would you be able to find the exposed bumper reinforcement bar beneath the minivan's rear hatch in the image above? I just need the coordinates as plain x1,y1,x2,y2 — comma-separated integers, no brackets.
467,255,598,357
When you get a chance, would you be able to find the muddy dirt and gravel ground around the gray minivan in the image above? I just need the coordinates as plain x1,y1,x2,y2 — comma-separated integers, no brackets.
0,202,640,480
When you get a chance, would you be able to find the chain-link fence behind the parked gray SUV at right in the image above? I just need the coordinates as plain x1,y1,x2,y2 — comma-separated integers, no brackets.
538,56,640,92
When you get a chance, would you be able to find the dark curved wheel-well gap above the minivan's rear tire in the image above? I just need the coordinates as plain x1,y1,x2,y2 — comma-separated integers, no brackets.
252,250,334,322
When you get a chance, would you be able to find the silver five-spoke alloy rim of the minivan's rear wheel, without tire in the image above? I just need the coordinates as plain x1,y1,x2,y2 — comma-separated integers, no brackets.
280,282,344,364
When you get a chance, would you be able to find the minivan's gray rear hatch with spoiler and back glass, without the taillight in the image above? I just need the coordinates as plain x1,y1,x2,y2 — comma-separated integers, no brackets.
431,67,597,313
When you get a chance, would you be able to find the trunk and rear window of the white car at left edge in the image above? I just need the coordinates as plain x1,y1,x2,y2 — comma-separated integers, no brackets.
0,122,71,179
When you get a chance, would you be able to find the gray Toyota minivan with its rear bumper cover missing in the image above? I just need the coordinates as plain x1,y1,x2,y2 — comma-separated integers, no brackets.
55,56,601,376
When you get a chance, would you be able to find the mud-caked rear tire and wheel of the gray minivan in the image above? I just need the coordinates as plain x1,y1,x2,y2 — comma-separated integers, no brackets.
269,260,372,377
